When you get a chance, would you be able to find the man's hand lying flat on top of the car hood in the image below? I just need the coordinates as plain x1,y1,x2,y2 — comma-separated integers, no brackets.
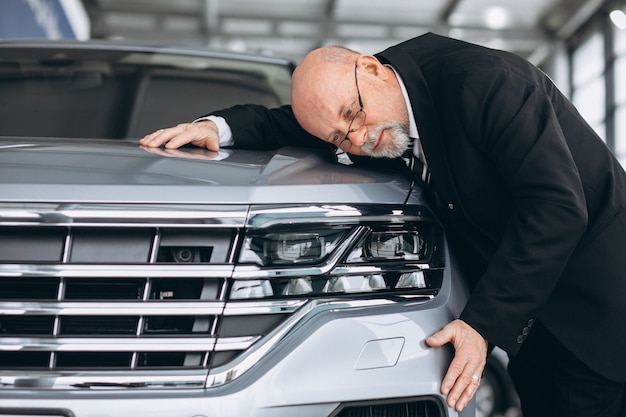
139,120,220,151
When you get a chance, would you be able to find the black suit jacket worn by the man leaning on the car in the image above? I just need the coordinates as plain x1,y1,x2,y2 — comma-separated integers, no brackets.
212,30,626,381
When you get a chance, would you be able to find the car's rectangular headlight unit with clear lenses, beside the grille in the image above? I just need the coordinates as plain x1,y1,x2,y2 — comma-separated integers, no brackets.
230,221,444,299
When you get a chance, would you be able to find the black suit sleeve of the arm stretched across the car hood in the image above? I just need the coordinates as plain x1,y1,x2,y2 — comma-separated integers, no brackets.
212,104,327,149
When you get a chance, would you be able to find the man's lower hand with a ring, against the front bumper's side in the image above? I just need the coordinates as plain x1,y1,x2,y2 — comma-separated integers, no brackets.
426,320,487,412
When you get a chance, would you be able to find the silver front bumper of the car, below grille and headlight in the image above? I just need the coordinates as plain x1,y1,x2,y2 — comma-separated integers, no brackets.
0,294,474,417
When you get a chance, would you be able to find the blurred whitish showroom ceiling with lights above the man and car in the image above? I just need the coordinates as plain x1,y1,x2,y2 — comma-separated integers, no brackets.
83,0,608,64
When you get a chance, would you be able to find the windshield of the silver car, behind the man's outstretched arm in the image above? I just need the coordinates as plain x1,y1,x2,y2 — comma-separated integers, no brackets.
0,46,291,139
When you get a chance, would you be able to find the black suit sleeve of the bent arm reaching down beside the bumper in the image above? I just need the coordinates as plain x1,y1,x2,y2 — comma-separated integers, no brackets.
455,66,588,354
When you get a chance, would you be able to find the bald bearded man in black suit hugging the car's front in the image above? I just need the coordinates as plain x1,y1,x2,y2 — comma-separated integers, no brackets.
141,34,626,417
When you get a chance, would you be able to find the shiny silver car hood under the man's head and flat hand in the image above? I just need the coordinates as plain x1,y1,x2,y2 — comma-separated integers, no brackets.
0,138,409,204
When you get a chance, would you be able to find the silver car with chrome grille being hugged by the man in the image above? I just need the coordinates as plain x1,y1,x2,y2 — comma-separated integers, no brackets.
0,41,508,417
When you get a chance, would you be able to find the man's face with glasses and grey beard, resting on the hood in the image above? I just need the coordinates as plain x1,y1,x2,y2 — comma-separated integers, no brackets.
292,53,410,158
